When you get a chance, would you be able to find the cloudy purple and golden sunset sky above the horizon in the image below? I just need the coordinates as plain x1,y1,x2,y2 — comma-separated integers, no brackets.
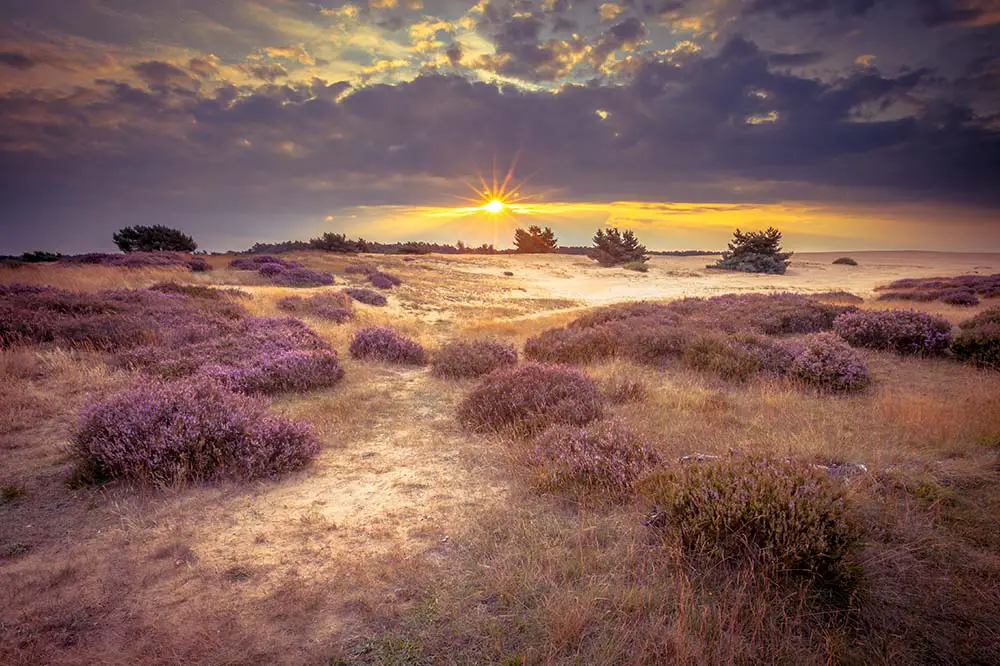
0,0,1000,254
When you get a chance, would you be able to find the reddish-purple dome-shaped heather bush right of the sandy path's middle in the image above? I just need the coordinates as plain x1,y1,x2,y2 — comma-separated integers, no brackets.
458,363,601,434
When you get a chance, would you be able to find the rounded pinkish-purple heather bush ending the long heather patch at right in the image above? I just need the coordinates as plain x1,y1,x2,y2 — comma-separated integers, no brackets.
789,333,872,393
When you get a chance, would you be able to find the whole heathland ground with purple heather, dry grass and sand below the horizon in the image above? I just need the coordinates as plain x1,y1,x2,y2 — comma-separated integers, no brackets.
0,251,1000,665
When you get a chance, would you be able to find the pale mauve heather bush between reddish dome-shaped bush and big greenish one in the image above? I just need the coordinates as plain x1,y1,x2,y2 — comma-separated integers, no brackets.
531,420,661,497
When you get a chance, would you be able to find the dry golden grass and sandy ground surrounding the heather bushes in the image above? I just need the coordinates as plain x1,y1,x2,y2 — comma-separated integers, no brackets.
0,253,1000,665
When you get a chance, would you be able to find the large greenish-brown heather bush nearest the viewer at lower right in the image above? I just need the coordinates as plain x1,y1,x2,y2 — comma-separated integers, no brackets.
640,458,860,585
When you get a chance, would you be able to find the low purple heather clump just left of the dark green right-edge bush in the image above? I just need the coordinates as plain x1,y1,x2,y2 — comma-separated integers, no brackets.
834,310,951,356
